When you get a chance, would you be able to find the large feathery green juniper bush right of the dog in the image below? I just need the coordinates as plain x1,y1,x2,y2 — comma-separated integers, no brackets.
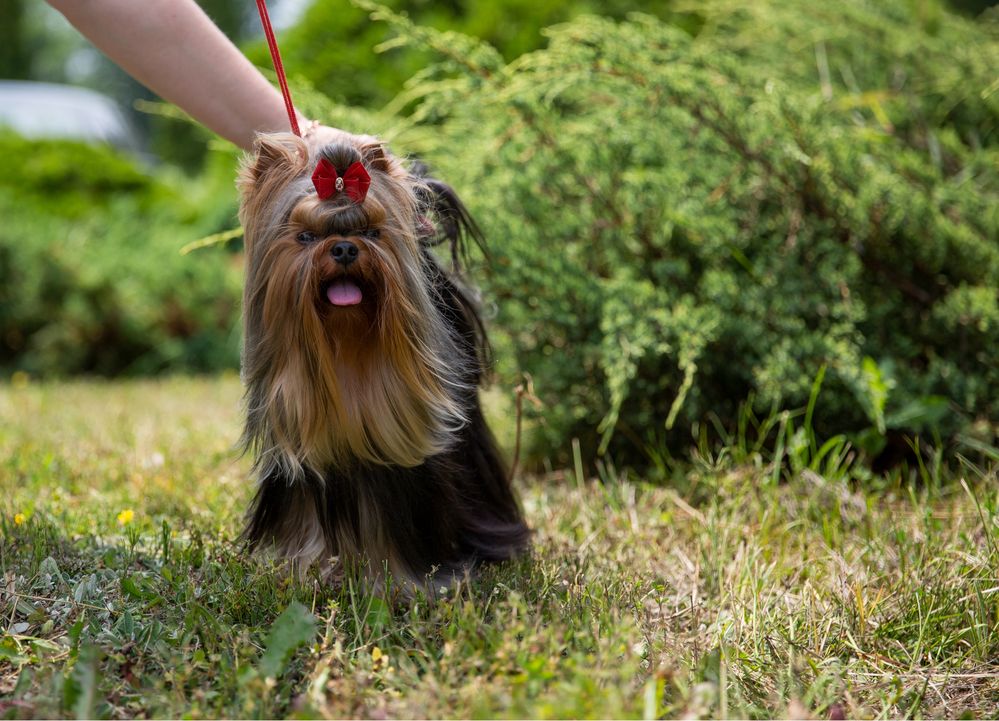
376,0,999,460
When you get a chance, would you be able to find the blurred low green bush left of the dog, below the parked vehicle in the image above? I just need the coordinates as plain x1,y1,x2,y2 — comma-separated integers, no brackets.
0,135,241,376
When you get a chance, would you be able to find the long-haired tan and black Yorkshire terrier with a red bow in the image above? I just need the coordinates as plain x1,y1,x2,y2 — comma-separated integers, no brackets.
238,134,529,588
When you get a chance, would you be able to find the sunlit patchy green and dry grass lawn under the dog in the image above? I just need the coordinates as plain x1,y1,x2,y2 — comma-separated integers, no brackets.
0,378,999,718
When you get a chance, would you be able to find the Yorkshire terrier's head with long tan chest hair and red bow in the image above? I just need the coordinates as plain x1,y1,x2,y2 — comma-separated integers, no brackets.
239,134,464,474
